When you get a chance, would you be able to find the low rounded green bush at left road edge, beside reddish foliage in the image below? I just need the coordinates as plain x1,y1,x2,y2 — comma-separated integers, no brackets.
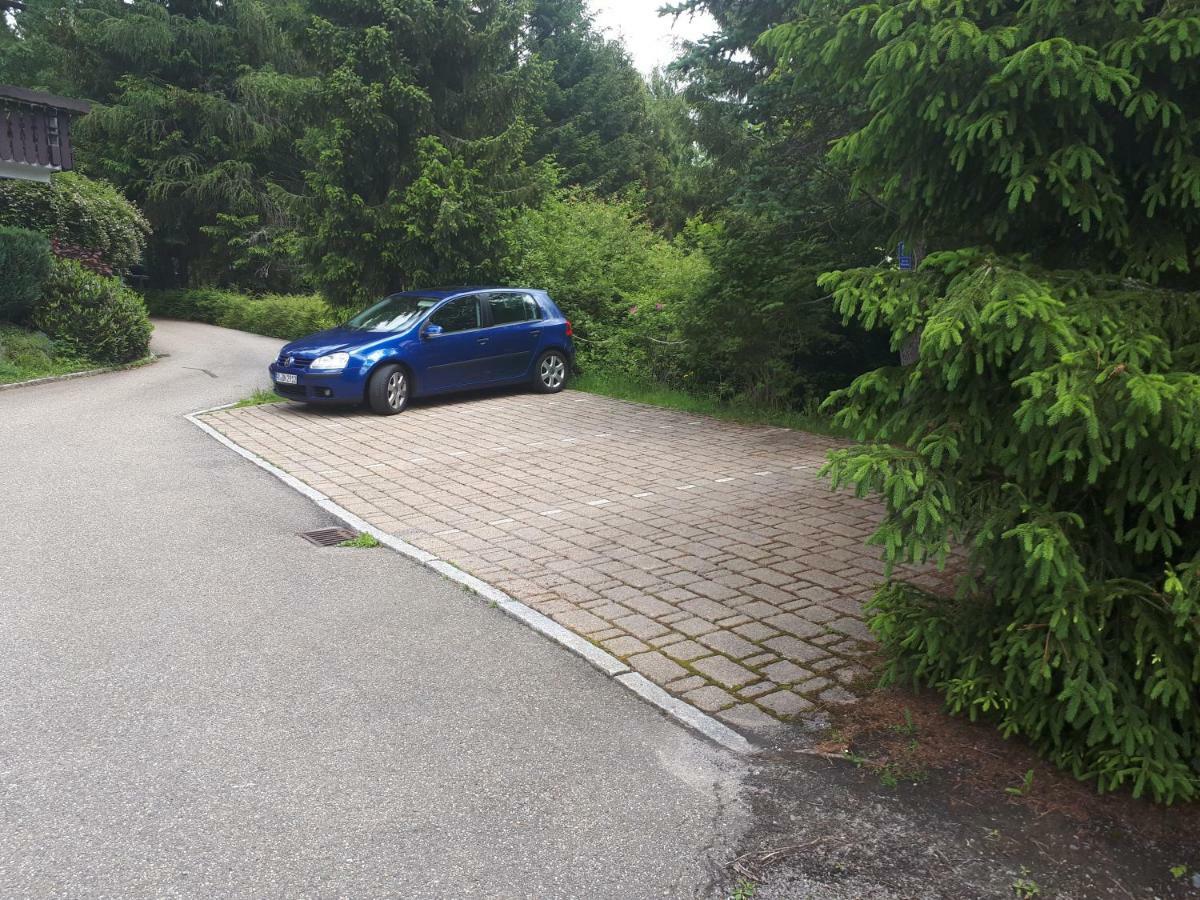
34,259,152,362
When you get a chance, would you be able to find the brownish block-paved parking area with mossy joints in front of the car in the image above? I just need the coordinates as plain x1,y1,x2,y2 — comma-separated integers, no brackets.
206,391,882,731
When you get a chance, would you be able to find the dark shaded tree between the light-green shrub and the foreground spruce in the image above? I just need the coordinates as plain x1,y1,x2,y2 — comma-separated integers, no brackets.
674,0,892,404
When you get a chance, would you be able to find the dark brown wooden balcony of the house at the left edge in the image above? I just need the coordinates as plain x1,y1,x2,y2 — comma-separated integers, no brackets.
0,84,90,181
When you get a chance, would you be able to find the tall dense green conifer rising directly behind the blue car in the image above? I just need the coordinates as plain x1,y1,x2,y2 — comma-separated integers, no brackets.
296,0,553,305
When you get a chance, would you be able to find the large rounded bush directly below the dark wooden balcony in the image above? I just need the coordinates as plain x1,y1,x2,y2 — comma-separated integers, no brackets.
0,172,150,270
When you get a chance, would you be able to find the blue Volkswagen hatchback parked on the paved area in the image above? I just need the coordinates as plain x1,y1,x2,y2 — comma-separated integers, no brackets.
270,288,575,415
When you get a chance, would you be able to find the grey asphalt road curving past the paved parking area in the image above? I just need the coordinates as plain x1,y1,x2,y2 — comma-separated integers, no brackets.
0,322,746,898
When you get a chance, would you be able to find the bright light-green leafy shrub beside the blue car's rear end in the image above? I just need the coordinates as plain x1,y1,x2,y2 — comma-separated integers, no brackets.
504,196,710,383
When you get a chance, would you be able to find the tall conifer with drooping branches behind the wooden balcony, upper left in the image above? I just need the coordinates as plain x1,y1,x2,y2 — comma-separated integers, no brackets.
0,0,316,286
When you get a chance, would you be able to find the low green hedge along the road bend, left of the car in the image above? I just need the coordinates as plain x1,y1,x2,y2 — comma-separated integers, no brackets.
146,288,337,341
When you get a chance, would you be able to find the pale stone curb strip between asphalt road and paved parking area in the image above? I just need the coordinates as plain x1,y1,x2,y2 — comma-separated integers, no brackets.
184,403,755,754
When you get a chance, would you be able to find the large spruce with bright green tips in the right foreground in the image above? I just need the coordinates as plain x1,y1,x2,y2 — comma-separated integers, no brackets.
764,0,1200,802
